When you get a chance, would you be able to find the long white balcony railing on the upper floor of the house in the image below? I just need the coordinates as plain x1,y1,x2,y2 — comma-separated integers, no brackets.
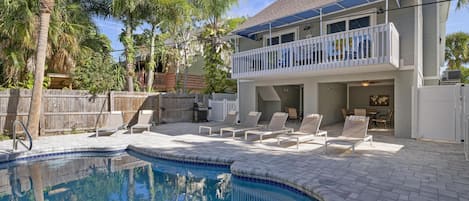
232,23,399,78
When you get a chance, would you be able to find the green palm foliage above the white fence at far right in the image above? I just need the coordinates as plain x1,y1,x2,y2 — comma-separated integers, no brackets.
445,32,469,69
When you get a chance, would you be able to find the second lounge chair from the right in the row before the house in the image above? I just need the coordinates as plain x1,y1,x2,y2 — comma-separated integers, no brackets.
277,114,327,149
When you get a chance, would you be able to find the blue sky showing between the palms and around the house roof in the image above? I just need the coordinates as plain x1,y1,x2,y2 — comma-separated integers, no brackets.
94,0,469,58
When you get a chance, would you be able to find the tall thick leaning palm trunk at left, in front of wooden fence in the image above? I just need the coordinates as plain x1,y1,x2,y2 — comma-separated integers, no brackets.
28,0,54,139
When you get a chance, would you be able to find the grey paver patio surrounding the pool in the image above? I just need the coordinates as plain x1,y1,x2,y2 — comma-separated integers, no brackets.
0,123,469,201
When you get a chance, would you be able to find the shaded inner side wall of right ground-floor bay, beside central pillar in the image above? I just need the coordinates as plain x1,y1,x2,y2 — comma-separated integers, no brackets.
318,83,347,125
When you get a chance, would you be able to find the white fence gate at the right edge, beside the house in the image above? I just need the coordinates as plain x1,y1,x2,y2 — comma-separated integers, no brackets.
417,85,469,160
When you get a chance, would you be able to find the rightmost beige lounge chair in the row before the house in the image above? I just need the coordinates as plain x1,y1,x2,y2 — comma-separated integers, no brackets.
324,116,373,153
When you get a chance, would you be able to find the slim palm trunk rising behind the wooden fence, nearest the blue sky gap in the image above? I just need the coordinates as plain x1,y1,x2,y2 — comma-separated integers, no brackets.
123,20,135,92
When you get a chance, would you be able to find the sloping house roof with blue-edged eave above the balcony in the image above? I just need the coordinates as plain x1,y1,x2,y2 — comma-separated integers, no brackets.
233,0,381,37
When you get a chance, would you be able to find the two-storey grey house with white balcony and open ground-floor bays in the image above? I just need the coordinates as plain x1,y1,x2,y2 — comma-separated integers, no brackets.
232,0,449,137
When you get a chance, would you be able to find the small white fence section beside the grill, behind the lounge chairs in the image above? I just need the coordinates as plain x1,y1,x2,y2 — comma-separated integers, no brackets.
208,99,239,121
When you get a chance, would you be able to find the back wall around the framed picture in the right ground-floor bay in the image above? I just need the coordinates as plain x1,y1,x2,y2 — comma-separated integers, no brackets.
349,85,394,112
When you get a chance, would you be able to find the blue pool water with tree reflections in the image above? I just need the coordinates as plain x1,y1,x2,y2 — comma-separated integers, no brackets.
0,152,315,201
